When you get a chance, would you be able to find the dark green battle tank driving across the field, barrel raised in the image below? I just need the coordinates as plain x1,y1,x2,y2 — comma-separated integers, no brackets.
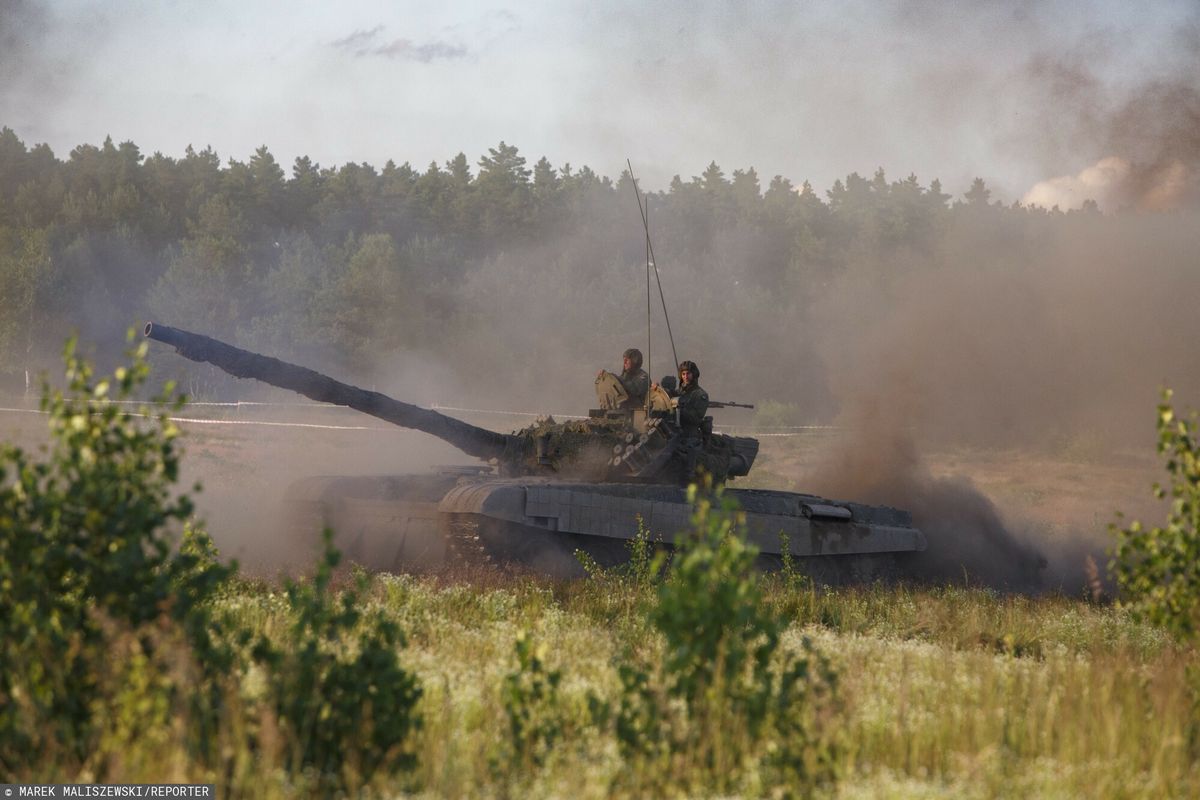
145,323,925,583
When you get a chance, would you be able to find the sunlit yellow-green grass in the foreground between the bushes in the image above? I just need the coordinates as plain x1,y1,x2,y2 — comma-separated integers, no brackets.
117,573,1185,798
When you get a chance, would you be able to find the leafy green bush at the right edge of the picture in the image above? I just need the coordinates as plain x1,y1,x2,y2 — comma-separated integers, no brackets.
1109,390,1200,639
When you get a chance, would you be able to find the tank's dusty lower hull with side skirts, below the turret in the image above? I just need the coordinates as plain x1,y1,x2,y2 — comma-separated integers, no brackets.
280,475,925,583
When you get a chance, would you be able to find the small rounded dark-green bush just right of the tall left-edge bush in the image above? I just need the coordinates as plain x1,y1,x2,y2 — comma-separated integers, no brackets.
253,529,421,787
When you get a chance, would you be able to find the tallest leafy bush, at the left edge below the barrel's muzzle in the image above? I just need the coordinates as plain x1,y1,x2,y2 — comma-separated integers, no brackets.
0,331,232,770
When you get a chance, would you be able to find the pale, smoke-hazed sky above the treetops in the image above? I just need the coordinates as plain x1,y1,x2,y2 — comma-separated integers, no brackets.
0,0,1200,201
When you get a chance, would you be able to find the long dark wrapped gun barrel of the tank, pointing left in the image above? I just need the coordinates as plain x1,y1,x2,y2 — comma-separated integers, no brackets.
145,323,521,461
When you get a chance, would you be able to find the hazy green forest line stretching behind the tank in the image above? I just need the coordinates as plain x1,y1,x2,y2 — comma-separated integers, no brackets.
0,127,1098,412
